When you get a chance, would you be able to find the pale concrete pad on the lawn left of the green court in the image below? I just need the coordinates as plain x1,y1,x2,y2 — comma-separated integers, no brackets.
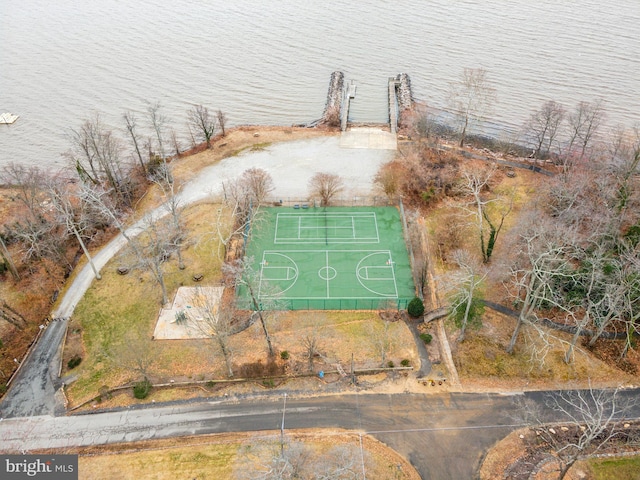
153,287,224,340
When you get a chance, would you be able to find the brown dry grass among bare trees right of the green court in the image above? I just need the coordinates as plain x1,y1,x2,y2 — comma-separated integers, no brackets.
426,163,638,389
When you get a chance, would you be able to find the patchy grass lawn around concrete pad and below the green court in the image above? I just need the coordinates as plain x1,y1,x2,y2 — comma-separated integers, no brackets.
63,204,418,407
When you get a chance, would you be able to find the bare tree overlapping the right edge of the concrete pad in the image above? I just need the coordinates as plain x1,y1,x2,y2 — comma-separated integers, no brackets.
191,288,235,377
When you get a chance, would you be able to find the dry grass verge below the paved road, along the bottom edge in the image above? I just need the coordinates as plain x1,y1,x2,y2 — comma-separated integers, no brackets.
79,430,420,480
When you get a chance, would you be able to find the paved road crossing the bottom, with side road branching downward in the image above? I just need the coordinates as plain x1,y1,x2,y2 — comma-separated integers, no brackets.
0,389,640,479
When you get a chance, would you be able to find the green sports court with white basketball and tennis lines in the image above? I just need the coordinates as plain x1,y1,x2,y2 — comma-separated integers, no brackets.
239,205,415,310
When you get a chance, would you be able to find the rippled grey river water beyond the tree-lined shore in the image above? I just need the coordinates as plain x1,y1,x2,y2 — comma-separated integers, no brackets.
0,0,640,166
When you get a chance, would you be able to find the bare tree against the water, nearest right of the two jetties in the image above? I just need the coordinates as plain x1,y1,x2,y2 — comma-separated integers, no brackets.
449,68,496,147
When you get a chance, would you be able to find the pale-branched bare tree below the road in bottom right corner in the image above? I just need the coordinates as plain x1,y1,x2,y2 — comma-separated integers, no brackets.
524,386,637,480
